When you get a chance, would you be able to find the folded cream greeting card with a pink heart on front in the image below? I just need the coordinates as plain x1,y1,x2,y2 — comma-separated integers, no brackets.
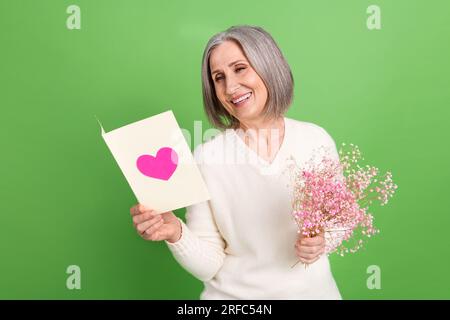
100,110,210,213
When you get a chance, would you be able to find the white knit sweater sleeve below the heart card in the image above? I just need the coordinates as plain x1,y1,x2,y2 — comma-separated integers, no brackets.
165,145,225,281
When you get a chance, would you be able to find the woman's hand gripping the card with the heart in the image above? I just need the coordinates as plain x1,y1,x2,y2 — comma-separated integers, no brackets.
130,203,181,243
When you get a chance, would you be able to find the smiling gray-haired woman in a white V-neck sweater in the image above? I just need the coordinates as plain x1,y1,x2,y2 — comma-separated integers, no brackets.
130,25,341,299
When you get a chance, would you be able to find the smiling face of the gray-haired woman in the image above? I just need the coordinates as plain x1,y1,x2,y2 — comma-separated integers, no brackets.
209,41,267,124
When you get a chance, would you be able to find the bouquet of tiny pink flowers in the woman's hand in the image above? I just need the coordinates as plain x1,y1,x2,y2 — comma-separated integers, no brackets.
288,143,397,266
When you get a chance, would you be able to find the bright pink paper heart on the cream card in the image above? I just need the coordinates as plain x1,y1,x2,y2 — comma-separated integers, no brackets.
136,147,178,181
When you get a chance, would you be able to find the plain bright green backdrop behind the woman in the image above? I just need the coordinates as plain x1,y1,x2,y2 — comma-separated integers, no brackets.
0,0,450,299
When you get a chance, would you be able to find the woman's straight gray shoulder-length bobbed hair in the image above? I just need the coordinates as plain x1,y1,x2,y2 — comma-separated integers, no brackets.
202,25,294,129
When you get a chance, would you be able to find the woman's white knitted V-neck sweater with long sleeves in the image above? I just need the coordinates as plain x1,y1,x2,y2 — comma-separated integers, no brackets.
165,117,341,300
